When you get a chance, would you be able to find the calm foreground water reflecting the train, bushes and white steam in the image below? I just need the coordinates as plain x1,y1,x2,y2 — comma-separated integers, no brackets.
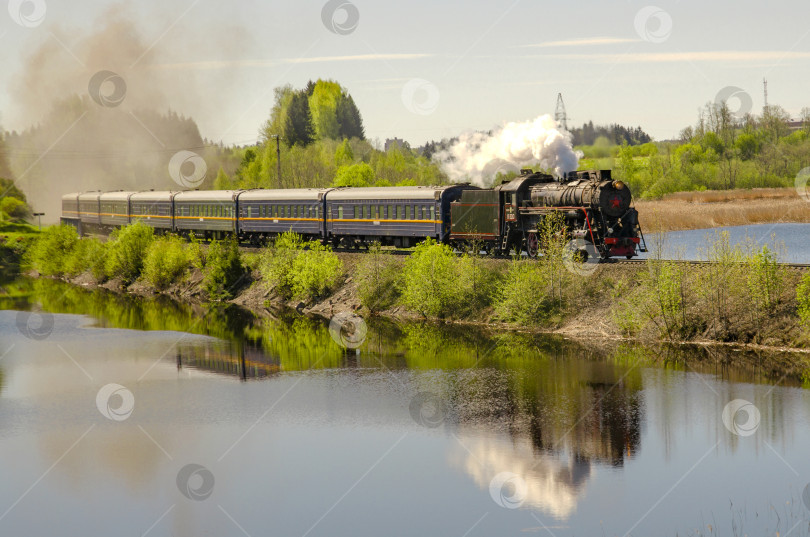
0,281,810,537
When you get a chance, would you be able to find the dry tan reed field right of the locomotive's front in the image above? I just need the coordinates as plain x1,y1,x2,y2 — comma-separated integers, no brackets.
636,188,810,231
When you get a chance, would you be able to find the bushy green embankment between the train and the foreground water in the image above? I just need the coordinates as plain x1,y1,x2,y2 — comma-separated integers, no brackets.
15,225,810,348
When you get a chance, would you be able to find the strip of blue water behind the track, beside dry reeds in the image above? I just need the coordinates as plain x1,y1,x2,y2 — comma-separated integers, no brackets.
640,224,810,263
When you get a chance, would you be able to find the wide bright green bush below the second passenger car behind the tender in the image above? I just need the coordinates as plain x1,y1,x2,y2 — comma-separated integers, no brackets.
259,231,343,299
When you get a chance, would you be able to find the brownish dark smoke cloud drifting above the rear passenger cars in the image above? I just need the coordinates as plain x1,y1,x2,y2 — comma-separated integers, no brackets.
5,4,249,222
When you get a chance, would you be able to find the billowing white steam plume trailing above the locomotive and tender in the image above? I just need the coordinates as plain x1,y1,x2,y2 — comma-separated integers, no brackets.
433,114,582,186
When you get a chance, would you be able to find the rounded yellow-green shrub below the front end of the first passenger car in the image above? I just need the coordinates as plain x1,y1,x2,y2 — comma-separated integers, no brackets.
402,239,459,317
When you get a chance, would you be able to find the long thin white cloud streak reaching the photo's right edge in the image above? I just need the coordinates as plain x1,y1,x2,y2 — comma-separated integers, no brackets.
527,50,810,63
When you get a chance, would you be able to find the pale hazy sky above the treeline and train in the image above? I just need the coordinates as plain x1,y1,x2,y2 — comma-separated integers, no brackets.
0,0,810,146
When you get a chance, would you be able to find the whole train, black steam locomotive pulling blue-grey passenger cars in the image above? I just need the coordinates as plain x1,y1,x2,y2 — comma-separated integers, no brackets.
61,170,643,259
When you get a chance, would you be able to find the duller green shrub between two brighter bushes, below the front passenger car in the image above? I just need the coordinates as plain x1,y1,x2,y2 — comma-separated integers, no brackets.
355,244,402,311
